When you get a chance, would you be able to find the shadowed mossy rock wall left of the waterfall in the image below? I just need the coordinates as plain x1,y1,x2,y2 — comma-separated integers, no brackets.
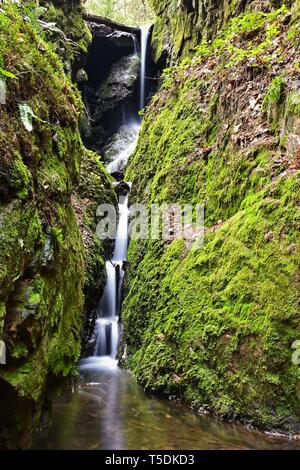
0,2,116,447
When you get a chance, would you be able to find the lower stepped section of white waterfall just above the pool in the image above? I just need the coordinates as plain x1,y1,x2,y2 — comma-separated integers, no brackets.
94,191,129,360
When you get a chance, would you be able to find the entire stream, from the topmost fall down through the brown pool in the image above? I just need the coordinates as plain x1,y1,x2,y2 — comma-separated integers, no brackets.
32,28,300,450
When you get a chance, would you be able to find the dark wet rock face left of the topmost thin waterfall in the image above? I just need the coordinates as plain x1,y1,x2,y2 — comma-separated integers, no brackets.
81,23,140,154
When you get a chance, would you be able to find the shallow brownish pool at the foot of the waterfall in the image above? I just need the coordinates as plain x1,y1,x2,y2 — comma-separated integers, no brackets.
33,358,300,450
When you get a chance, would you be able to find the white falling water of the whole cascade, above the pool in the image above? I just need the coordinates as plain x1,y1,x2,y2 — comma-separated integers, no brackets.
80,26,150,370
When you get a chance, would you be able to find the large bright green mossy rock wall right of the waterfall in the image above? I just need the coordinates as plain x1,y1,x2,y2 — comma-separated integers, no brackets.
122,1,300,433
